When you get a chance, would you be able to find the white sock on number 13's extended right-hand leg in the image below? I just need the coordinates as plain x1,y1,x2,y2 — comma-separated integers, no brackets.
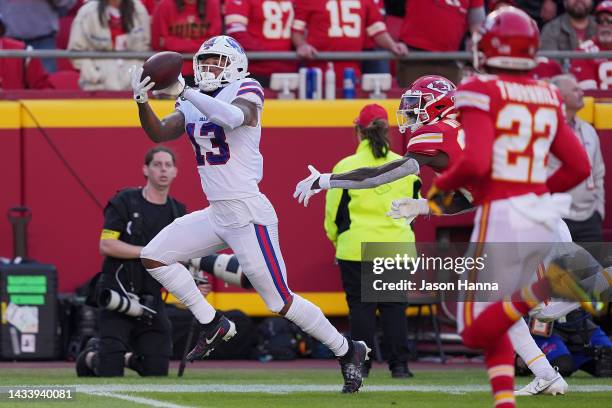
285,293,348,357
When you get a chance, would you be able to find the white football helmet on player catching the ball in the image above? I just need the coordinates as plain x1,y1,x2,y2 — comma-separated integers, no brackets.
193,35,249,92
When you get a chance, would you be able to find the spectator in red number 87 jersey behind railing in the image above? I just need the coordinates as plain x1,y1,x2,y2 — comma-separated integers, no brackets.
225,0,297,87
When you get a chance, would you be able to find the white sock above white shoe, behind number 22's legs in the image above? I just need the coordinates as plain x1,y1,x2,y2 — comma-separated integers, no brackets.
508,319,557,380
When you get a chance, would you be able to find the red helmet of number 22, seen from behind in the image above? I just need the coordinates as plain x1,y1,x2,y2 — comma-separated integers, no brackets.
473,6,540,71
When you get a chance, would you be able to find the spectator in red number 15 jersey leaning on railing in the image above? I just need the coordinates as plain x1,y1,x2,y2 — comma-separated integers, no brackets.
291,0,408,86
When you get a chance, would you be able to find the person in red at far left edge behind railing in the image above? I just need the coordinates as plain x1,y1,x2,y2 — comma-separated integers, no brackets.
0,14,53,90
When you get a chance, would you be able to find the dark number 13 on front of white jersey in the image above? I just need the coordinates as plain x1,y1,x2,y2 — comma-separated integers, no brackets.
185,122,230,166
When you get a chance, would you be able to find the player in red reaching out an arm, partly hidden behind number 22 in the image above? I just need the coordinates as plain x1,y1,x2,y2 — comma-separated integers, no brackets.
296,75,567,395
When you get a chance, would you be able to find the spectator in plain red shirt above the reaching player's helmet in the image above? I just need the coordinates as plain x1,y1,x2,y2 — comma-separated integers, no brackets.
397,0,485,87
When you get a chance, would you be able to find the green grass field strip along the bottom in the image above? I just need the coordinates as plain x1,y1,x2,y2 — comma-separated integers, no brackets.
0,368,612,408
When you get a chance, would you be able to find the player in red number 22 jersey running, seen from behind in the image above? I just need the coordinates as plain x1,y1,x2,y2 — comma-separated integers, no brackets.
428,7,591,408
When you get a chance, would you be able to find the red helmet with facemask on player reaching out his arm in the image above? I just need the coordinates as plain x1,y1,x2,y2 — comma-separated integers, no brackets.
396,75,457,133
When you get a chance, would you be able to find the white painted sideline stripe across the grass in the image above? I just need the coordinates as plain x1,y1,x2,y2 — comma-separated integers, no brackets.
70,383,612,396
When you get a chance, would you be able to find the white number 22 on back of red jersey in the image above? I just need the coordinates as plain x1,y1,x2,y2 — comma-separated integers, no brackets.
492,104,558,183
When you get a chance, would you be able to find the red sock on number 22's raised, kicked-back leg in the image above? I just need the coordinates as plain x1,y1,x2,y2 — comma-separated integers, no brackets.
461,279,550,349
